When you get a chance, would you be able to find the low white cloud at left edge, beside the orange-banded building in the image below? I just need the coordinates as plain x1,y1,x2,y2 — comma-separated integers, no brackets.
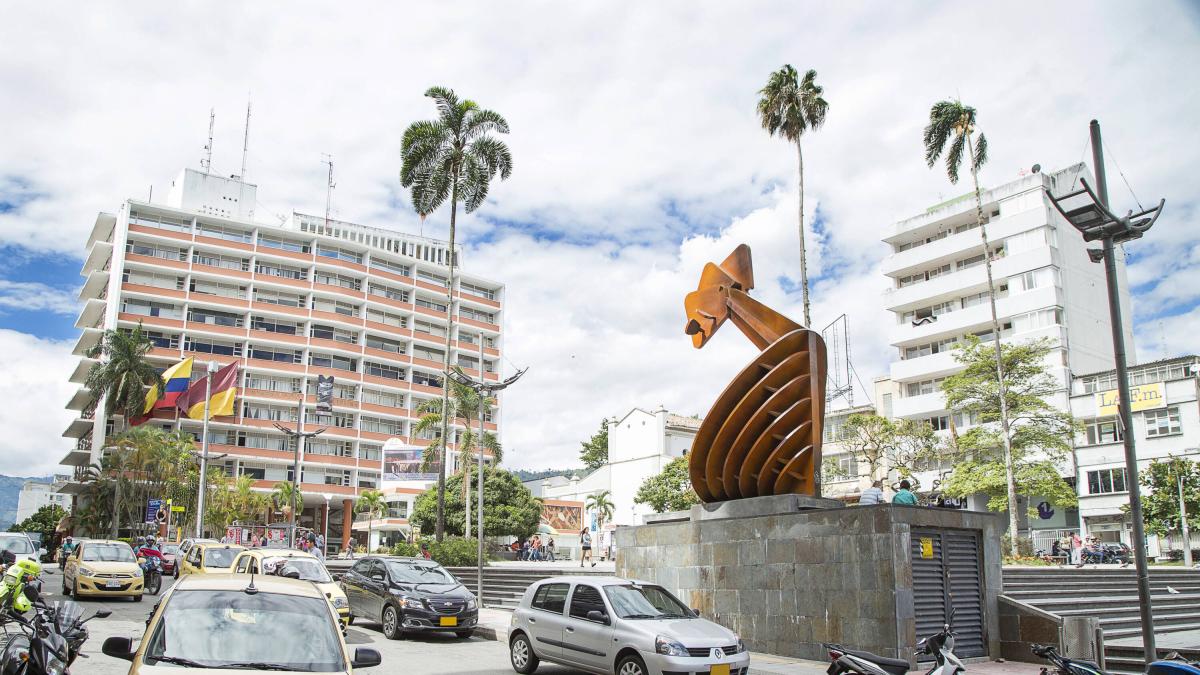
0,329,78,476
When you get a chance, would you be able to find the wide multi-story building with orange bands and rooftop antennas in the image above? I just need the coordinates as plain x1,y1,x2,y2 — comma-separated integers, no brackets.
62,169,504,545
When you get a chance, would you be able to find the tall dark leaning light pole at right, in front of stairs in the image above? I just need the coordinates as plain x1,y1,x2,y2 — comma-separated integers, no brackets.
1050,120,1165,665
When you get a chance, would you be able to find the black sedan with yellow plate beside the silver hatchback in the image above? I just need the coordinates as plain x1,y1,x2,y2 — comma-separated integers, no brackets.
341,556,479,640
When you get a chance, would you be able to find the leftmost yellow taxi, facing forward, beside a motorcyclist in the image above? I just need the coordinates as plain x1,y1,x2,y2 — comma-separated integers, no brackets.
62,539,142,602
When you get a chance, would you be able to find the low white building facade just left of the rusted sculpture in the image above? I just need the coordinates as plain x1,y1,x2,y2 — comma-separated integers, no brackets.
526,407,701,525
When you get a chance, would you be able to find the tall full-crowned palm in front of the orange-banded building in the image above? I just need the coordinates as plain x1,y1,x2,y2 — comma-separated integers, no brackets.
400,86,512,542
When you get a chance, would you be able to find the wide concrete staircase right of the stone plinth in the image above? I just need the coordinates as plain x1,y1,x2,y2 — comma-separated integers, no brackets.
1004,567,1200,673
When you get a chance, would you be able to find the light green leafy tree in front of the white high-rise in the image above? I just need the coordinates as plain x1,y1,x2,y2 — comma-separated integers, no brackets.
942,336,1078,516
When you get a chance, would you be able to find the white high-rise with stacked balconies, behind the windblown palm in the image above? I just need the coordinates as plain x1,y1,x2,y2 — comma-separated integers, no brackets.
882,165,1134,511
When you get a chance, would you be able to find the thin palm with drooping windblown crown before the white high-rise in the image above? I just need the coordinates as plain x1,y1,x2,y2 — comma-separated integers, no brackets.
924,101,1019,557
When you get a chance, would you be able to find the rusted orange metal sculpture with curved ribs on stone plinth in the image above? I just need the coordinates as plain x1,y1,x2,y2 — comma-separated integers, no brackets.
683,244,826,502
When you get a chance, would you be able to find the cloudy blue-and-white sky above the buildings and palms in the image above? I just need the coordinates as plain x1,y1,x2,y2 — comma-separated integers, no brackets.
0,1,1200,476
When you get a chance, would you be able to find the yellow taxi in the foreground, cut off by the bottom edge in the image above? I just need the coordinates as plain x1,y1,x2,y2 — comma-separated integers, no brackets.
101,574,382,675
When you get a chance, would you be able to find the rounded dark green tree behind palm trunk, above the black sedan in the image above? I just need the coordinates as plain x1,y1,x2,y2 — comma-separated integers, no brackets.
409,466,541,539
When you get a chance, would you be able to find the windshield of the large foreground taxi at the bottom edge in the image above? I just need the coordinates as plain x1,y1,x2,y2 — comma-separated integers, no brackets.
144,590,346,673
